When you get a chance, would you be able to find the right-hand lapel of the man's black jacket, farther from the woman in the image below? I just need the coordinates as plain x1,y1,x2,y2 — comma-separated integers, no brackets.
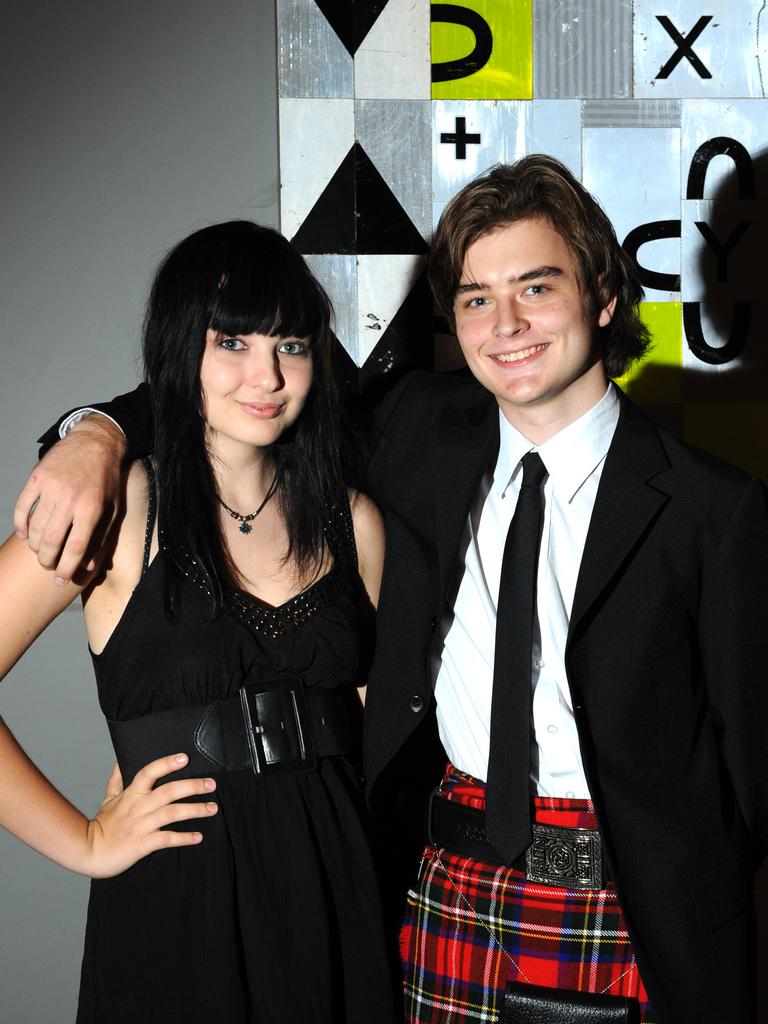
568,395,670,642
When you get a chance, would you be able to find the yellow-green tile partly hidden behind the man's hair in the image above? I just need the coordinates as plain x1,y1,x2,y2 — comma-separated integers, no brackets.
616,302,683,406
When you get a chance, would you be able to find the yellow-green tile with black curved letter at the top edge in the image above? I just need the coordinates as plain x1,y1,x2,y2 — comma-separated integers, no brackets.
432,0,534,99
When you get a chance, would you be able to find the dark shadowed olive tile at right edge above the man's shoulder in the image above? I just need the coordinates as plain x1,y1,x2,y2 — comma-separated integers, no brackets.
683,401,768,480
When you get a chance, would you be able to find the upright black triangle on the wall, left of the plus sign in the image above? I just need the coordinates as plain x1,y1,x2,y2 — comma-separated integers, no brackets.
292,142,428,256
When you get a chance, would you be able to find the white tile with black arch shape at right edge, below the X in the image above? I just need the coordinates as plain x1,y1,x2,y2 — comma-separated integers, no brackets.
682,99,768,199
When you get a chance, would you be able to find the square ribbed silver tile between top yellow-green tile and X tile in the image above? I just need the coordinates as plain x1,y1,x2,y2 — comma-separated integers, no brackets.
534,0,632,99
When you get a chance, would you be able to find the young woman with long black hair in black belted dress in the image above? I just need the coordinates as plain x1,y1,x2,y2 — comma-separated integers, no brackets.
0,222,392,1024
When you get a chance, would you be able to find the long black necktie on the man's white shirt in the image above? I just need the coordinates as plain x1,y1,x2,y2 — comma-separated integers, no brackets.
485,452,547,864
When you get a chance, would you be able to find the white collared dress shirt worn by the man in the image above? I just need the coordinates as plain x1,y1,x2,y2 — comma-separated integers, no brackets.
434,385,618,799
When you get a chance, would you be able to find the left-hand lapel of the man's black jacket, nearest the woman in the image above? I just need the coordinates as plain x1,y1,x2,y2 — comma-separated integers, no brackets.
434,389,499,597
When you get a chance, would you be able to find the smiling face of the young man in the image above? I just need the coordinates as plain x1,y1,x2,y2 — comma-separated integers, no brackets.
454,218,615,443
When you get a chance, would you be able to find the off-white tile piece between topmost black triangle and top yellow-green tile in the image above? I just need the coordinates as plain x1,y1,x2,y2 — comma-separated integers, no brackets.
354,0,431,99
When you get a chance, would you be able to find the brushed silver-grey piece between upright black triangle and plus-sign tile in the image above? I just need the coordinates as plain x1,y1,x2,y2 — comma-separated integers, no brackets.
354,99,432,239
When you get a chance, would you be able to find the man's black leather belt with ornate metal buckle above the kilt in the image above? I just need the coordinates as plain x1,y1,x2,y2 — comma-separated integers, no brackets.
427,791,607,889
